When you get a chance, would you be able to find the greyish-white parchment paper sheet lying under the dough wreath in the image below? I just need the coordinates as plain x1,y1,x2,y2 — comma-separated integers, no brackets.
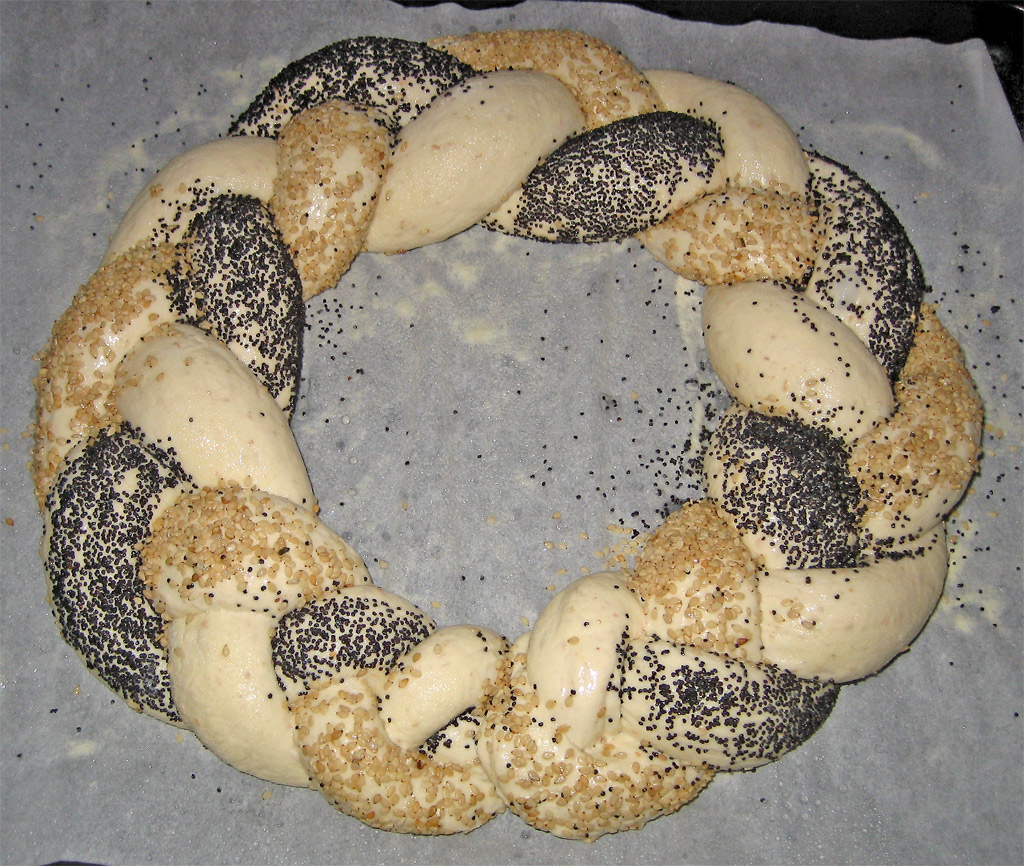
0,2,1024,864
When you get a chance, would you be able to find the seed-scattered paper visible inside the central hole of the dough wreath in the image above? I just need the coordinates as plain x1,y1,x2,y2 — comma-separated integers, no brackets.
292,228,717,636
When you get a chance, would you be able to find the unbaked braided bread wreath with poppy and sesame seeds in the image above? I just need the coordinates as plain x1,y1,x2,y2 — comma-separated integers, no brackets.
33,31,981,839
